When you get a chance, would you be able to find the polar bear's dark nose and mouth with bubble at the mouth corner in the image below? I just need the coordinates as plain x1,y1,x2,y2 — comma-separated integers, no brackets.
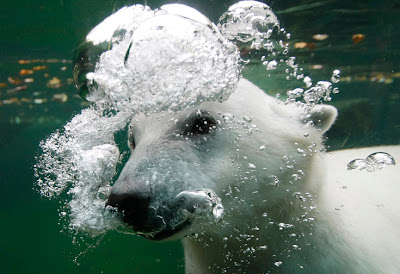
106,189,224,240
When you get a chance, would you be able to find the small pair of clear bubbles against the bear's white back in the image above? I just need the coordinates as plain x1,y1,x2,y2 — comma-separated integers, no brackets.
347,152,396,172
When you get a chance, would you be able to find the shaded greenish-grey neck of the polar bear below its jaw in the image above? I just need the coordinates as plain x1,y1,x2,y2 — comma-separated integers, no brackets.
183,193,364,273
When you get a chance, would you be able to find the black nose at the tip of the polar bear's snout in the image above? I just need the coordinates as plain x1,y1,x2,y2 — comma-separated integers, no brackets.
106,193,152,232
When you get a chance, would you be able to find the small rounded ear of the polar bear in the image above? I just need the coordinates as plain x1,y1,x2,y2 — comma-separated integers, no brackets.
309,105,337,133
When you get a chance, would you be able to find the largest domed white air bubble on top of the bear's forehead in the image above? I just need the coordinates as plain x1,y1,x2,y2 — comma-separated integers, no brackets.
74,4,240,112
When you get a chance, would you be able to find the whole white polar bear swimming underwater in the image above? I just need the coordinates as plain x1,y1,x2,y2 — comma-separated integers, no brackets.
107,79,400,273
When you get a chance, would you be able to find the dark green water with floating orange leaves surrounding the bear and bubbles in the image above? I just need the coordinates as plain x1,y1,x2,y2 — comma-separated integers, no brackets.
0,1,400,273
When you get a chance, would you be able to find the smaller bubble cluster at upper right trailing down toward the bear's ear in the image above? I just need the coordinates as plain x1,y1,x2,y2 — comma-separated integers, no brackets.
218,1,340,114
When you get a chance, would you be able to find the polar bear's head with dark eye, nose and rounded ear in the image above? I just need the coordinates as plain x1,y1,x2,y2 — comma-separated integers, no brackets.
107,79,337,240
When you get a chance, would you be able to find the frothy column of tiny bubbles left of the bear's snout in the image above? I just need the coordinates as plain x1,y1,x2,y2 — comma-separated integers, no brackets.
35,107,128,235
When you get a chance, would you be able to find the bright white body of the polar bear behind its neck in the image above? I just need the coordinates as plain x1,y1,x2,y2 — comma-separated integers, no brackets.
316,146,400,273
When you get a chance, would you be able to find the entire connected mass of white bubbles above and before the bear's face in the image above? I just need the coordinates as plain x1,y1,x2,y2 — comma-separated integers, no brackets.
35,1,340,237
